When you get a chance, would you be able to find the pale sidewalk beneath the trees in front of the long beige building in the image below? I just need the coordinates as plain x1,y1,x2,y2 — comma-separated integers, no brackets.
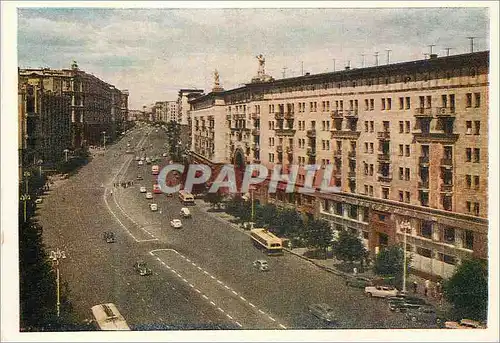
197,199,449,310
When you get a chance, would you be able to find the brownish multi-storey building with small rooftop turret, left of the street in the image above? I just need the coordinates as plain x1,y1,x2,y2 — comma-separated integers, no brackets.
19,62,128,149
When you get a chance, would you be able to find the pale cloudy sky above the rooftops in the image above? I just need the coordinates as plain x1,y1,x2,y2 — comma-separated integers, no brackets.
17,2,490,109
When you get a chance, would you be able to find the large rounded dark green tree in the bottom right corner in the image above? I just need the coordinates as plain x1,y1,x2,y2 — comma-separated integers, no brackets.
443,259,488,320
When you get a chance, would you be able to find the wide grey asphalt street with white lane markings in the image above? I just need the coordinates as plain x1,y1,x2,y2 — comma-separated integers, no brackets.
38,127,420,330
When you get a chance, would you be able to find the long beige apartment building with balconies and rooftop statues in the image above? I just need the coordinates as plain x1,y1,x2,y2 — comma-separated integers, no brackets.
190,51,489,277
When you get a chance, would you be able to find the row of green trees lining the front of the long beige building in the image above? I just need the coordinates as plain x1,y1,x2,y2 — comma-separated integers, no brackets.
205,193,488,321
